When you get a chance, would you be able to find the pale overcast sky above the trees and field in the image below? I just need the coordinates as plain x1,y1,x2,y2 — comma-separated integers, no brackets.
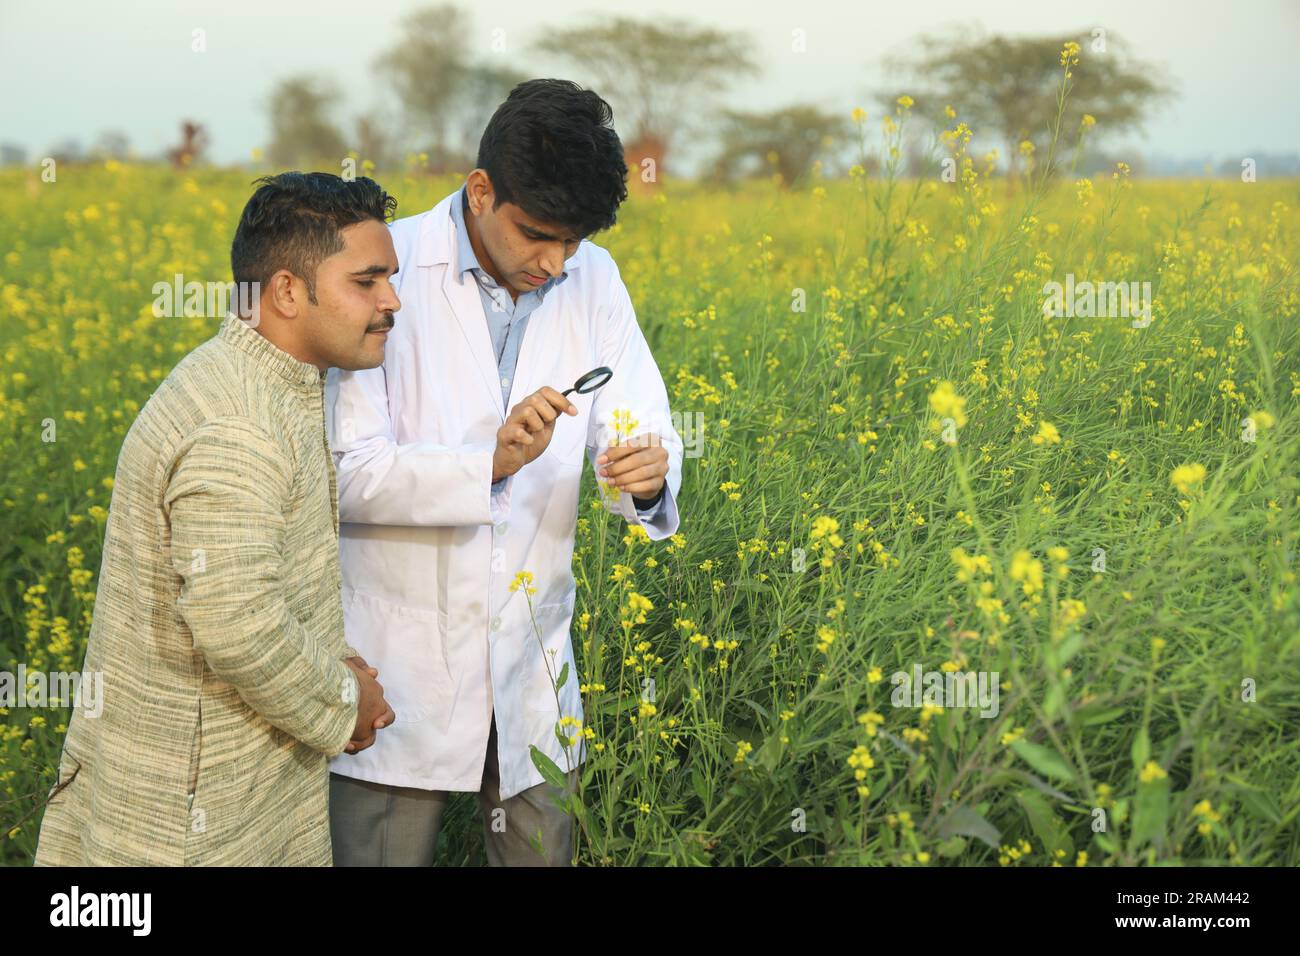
0,0,1300,170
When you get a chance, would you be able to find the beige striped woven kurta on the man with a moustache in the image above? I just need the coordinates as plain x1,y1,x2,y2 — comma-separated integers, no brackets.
35,316,361,866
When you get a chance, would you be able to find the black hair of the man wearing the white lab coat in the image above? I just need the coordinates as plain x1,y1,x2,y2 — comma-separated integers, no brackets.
477,79,628,237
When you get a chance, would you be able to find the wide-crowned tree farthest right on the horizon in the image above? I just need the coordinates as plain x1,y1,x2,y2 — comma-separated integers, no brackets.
881,29,1174,176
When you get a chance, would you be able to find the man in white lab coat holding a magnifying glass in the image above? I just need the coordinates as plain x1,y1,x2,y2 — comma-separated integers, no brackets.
326,79,683,865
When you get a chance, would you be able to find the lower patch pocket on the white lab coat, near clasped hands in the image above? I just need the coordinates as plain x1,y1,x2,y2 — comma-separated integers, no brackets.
343,591,451,723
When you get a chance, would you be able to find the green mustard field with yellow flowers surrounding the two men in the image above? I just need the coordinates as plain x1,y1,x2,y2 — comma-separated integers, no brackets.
0,151,1300,866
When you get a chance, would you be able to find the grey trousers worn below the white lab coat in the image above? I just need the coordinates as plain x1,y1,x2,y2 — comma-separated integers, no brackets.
329,714,577,866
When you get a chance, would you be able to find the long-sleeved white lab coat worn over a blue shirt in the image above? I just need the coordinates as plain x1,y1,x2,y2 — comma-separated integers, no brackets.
325,190,683,800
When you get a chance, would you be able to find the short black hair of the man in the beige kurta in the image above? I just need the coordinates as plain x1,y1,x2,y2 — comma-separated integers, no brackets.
230,172,398,306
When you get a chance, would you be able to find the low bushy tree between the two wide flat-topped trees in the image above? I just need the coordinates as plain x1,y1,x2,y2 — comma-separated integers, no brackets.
712,105,848,189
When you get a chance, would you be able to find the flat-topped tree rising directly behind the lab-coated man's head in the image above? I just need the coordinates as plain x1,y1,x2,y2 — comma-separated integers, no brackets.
533,17,758,179
